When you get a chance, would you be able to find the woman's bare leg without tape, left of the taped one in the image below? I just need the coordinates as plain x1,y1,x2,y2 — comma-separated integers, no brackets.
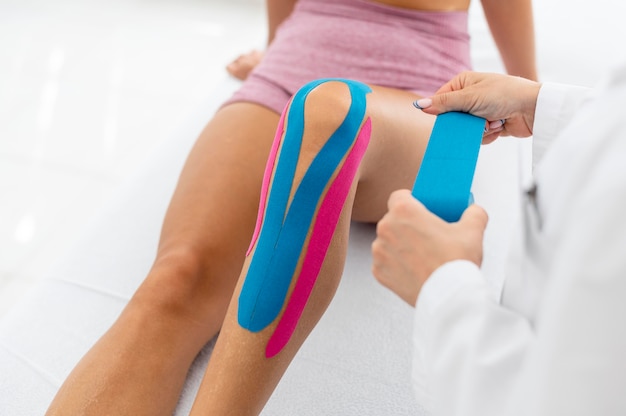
48,103,279,416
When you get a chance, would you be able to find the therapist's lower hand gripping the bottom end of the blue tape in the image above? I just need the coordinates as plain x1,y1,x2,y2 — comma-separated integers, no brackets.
372,190,487,306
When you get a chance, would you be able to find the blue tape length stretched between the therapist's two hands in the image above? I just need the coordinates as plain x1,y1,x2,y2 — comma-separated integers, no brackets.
412,112,485,222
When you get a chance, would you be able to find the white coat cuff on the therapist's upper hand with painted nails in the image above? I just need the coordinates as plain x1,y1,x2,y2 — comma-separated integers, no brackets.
533,83,594,170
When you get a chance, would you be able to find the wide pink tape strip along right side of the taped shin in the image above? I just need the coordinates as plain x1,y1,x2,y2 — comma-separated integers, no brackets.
264,118,372,358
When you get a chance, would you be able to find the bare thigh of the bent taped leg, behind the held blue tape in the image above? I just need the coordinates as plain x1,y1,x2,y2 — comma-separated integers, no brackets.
352,86,435,222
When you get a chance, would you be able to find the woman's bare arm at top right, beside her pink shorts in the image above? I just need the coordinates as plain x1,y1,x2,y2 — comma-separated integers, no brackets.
481,0,537,80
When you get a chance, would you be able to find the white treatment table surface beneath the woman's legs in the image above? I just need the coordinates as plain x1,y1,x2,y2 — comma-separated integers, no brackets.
0,79,422,415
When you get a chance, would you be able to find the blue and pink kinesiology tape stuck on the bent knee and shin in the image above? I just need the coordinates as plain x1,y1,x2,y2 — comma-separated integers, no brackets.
237,79,371,358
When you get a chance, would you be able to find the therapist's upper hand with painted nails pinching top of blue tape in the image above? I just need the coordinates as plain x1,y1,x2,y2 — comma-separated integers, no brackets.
418,72,541,144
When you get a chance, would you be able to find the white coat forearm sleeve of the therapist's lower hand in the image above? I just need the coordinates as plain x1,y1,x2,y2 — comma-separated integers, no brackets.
412,260,534,416
